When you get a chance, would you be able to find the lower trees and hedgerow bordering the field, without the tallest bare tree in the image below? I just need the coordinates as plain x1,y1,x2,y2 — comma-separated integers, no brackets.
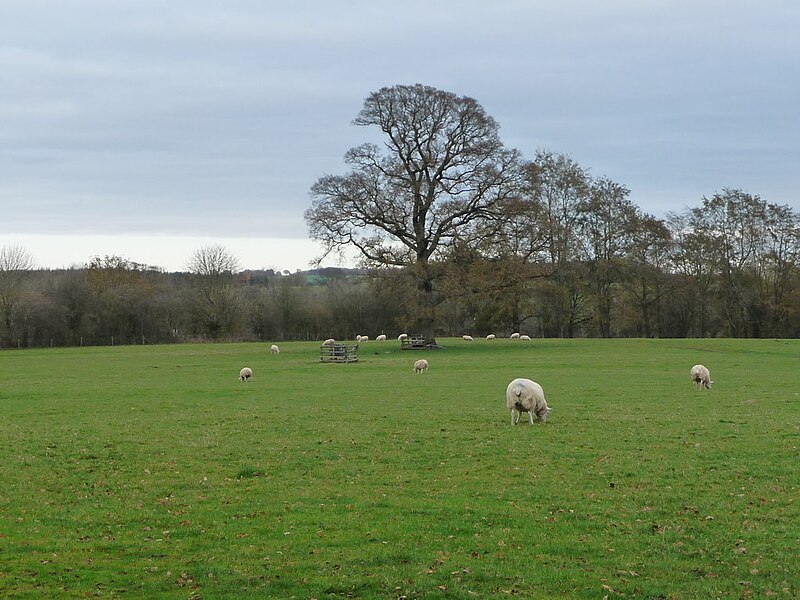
0,183,800,348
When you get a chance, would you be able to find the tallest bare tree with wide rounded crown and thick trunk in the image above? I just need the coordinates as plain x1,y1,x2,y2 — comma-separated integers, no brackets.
305,84,520,335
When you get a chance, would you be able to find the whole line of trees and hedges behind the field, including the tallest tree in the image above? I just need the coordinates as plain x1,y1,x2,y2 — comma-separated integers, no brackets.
0,84,800,347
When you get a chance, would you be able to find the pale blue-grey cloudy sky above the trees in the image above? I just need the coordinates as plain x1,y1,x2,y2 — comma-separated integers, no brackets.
0,0,800,271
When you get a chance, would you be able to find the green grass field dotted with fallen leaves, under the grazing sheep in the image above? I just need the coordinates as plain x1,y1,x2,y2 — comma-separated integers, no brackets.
0,339,800,600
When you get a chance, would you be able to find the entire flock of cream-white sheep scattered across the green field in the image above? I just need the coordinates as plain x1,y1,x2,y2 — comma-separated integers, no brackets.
239,333,714,425
